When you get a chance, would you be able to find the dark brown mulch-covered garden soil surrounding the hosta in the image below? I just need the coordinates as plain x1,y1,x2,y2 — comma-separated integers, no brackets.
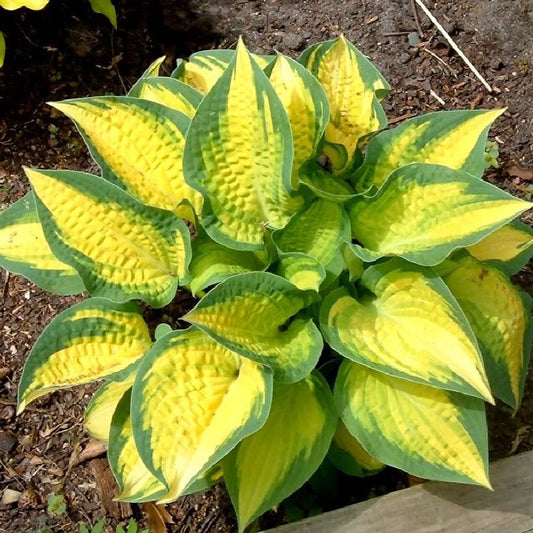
0,0,533,533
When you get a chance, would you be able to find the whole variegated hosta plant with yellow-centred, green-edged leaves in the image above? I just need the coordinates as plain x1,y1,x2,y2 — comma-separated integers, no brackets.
0,37,533,530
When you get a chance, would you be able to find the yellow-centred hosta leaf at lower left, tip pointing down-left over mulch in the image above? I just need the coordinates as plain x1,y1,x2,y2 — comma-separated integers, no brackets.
18,298,152,412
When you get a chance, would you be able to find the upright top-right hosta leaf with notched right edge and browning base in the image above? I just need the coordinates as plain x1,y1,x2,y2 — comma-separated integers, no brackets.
299,36,390,174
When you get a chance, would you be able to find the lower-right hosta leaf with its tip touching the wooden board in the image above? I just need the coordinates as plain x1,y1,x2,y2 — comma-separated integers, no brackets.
335,361,490,488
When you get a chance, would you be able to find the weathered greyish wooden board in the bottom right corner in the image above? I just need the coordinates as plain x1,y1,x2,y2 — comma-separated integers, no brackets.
269,451,533,533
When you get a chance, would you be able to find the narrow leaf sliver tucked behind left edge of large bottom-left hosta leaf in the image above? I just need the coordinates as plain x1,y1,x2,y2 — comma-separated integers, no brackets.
107,389,167,502
